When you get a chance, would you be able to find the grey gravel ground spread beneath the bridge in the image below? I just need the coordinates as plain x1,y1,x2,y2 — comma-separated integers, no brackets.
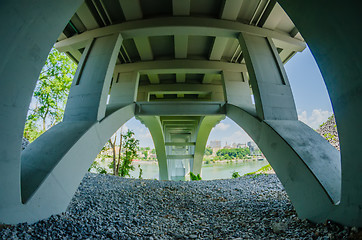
0,173,361,239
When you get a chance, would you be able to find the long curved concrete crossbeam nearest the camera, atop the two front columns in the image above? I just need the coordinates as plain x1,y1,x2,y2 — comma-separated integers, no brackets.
55,17,306,51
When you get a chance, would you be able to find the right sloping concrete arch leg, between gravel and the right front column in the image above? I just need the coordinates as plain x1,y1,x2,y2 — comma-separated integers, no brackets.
227,104,341,222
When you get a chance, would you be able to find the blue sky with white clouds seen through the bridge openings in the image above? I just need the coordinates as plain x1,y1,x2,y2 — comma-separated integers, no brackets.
124,48,333,148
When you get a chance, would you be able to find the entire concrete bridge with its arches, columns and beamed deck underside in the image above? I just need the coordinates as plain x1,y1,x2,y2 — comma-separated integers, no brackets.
0,0,362,227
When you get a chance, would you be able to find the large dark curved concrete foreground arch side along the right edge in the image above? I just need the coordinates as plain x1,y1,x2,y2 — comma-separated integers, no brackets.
278,0,362,227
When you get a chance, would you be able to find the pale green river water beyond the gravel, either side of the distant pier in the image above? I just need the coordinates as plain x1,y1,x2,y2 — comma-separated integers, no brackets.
131,160,268,180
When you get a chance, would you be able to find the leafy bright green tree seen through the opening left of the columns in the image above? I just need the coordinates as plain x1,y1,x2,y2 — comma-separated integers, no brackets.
24,48,77,141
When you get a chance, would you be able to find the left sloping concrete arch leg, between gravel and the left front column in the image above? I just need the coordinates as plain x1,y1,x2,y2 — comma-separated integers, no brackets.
0,104,135,224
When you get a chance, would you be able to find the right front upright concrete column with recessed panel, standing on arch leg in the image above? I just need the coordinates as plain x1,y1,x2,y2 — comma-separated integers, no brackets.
239,33,298,120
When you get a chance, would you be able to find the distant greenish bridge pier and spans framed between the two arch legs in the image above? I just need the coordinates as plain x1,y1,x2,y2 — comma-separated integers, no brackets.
137,115,225,180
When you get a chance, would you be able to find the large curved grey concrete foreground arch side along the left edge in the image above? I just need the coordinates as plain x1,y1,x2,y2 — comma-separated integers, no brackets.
0,0,83,222
